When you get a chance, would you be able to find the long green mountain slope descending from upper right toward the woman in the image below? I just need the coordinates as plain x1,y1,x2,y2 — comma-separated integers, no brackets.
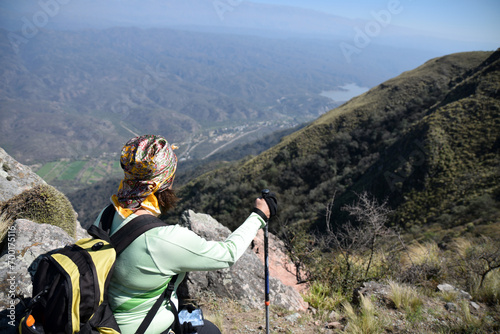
174,51,500,234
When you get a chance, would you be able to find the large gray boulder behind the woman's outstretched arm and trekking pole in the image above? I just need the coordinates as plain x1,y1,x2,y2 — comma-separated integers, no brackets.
179,210,307,311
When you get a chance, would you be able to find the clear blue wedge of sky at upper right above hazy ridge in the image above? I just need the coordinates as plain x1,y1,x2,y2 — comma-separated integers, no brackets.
252,0,500,43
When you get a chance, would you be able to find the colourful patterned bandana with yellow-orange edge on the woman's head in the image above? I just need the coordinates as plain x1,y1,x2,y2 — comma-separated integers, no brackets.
112,135,177,217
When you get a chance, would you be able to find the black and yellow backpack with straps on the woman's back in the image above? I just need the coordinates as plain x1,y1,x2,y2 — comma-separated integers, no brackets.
19,205,177,334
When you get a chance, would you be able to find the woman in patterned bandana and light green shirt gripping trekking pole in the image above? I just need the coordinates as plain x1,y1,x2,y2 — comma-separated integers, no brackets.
95,135,270,334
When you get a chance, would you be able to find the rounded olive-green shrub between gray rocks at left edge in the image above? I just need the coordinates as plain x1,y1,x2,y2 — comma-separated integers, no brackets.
0,184,76,238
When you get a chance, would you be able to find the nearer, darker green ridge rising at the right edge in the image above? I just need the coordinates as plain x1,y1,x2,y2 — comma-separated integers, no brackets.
376,52,500,227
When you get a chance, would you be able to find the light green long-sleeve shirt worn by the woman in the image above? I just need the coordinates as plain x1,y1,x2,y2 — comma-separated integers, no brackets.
94,212,265,334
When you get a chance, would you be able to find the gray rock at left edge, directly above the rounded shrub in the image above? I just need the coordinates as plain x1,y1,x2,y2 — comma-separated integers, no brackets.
0,147,46,202
